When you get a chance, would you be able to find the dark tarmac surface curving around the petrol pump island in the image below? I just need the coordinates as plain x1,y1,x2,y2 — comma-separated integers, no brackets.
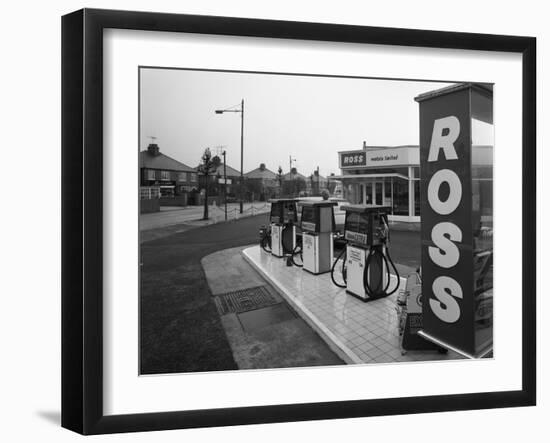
140,214,420,374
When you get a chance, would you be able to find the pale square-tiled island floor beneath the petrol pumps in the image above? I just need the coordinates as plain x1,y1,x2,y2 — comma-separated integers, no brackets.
243,246,461,363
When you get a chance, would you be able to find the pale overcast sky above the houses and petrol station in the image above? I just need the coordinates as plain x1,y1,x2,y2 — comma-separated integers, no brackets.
140,68,448,176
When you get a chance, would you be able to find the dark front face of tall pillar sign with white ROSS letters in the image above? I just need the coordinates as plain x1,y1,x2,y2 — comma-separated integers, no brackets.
415,85,496,356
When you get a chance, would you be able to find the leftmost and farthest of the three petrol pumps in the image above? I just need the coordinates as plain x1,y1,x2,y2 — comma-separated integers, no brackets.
269,199,298,257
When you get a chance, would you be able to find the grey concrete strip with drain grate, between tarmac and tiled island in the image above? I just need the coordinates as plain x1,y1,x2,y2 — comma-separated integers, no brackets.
201,247,344,369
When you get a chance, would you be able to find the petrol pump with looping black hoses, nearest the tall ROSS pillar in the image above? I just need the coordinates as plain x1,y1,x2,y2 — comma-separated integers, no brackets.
331,205,399,302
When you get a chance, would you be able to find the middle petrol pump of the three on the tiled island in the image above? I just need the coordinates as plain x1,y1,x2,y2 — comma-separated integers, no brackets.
301,201,336,274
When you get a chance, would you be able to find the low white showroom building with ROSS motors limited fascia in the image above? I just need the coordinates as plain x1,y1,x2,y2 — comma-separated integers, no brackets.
334,143,420,222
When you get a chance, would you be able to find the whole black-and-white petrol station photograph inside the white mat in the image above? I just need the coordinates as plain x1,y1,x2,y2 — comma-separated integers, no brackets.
136,66,496,376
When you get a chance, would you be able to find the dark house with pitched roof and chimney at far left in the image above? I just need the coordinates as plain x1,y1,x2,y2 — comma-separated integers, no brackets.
139,143,198,197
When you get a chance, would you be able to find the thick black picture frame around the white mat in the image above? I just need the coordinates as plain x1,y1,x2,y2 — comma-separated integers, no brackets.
62,9,537,434
